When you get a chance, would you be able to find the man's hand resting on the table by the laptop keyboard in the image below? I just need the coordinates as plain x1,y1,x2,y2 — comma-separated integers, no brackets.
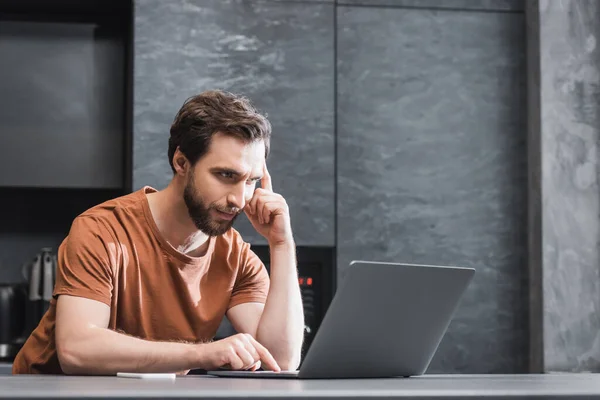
200,333,281,372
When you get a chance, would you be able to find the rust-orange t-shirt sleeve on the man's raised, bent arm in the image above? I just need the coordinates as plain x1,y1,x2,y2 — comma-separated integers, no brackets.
228,243,269,309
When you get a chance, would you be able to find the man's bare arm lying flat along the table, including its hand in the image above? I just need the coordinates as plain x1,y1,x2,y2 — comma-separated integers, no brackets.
55,295,278,375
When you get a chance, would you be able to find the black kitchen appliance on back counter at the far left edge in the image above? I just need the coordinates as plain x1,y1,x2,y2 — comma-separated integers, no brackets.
0,283,27,361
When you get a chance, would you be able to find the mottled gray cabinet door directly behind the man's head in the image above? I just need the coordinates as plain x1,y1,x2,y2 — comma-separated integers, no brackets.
133,0,334,246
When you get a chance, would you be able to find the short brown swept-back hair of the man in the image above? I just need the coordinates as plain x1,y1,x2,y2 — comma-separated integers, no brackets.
169,90,271,173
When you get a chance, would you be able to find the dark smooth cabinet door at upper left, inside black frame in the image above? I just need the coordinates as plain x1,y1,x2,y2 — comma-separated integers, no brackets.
0,18,126,189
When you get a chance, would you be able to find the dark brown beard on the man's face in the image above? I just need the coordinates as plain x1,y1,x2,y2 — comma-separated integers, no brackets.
183,175,239,236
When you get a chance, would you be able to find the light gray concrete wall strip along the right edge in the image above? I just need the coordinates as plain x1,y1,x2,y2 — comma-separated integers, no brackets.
527,0,600,372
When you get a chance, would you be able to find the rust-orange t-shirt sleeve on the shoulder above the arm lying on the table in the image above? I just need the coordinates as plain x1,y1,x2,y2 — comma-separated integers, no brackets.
54,216,113,306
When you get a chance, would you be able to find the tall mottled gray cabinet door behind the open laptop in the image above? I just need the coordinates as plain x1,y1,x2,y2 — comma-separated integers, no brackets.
337,7,528,373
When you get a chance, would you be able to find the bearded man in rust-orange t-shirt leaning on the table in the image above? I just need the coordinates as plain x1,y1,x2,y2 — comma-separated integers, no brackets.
13,91,304,375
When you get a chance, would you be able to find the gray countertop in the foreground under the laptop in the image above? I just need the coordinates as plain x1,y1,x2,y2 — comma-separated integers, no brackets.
0,374,600,400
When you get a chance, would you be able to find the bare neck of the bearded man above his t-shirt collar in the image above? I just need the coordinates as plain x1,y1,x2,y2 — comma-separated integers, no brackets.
146,184,209,257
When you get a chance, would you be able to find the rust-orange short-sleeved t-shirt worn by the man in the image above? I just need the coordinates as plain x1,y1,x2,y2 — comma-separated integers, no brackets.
13,187,269,374
